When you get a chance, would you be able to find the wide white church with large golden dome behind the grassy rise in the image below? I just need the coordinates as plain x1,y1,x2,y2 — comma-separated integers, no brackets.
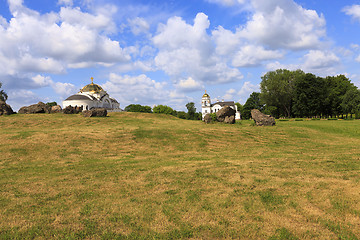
63,78,120,110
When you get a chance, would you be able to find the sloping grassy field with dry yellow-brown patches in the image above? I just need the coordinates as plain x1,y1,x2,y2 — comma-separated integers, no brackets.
0,113,360,239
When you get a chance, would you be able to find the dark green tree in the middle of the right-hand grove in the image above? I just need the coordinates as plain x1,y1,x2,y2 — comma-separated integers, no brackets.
292,73,325,117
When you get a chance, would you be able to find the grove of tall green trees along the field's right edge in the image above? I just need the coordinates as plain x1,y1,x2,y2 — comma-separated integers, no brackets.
238,69,360,119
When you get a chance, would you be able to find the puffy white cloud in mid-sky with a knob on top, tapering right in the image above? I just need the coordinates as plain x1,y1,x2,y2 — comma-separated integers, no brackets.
153,13,242,84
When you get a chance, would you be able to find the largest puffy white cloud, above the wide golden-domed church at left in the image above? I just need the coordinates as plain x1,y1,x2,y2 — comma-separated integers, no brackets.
0,0,130,88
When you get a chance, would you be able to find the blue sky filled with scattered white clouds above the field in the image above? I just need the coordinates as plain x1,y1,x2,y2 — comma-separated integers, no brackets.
0,0,360,110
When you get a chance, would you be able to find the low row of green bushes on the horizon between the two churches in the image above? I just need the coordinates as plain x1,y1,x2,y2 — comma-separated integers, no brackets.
124,102,202,120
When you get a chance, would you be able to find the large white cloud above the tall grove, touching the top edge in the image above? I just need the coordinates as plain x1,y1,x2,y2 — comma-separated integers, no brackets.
238,0,326,49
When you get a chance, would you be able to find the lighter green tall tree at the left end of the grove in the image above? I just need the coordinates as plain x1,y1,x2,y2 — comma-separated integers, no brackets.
260,69,304,117
